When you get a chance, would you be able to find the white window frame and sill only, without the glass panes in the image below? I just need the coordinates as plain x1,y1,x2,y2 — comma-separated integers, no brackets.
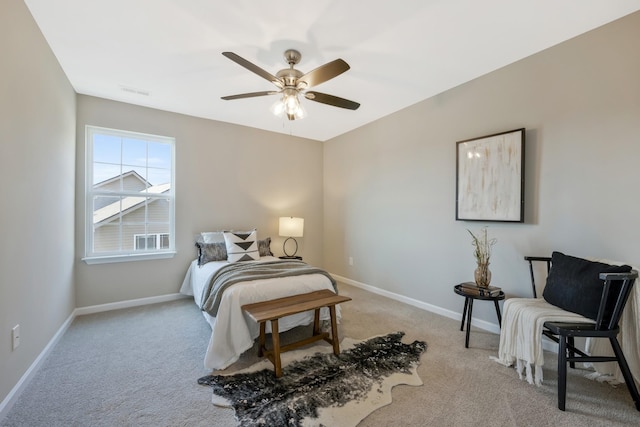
82,125,176,264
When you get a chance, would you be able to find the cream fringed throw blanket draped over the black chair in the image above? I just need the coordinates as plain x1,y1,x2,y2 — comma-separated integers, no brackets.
492,259,640,385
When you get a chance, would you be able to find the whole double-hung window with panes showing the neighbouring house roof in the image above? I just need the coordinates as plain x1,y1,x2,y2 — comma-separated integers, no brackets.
84,126,175,263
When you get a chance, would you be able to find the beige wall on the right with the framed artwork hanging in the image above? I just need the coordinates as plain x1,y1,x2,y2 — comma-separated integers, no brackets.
324,13,640,324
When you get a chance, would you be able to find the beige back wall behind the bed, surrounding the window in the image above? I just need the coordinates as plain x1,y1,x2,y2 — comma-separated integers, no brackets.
76,96,323,307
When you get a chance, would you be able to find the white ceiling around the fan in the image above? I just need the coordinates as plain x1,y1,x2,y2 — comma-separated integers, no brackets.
25,0,640,141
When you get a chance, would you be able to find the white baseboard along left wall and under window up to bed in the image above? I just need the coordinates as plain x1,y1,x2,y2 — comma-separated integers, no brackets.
0,294,191,421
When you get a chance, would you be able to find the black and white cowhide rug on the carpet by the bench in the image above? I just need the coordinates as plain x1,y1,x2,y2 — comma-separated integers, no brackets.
198,332,427,426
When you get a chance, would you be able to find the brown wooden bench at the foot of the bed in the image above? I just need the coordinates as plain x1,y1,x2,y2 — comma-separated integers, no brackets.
242,289,351,377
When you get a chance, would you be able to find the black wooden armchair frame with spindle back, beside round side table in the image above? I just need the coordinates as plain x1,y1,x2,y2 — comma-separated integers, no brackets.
525,257,640,411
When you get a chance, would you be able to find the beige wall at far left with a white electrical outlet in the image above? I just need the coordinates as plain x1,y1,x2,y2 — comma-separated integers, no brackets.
0,0,75,406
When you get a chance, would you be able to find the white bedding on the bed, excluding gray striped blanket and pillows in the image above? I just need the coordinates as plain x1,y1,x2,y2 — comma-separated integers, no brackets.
180,256,340,369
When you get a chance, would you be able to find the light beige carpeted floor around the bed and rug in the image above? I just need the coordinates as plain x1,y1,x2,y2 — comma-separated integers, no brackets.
0,284,640,427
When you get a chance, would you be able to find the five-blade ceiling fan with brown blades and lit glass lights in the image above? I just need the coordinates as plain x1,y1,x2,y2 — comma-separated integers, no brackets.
222,49,360,120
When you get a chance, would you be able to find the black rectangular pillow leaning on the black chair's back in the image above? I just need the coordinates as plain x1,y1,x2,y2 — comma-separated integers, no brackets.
542,252,631,320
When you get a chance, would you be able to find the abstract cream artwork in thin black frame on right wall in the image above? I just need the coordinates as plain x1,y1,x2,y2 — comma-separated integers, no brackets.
456,128,525,222
